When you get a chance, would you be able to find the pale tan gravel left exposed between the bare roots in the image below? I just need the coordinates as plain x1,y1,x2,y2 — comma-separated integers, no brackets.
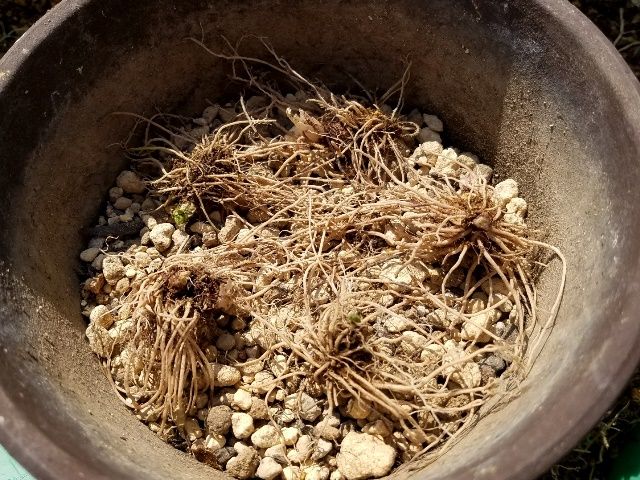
80,99,527,480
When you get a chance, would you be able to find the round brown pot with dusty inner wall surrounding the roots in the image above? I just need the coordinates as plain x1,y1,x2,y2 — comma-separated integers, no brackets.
0,0,639,479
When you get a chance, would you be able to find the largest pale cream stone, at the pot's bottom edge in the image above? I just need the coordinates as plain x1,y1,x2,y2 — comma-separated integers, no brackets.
336,432,396,480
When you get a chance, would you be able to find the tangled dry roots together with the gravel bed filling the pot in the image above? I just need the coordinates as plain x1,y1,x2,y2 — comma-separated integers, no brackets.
83,42,564,478
